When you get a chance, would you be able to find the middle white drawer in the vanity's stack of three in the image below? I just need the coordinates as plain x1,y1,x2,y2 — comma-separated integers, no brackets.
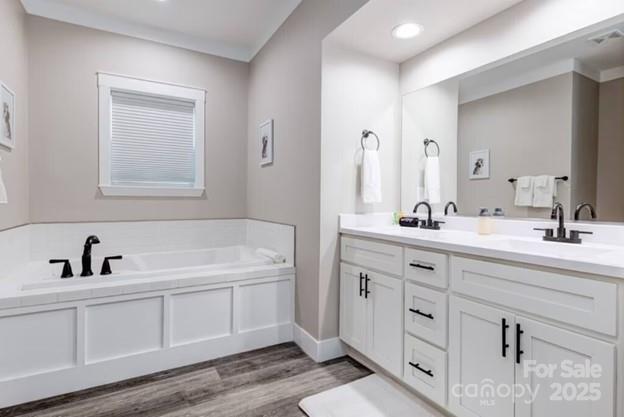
405,282,448,349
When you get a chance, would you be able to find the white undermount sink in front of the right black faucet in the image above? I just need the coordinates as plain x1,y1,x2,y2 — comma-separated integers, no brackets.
482,239,611,258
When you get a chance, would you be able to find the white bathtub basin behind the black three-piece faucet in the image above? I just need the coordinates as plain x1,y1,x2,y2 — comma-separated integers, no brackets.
18,246,279,291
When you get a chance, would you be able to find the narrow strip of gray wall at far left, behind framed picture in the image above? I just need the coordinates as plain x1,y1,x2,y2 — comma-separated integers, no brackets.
0,0,29,230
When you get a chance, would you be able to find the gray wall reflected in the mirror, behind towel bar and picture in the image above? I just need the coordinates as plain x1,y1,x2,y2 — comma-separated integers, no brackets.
457,73,573,217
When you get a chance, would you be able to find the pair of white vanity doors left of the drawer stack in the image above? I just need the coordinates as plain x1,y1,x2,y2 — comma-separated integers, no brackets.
340,263,403,376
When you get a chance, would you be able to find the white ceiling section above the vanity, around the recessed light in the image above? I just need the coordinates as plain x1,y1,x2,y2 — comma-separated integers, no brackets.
330,0,522,63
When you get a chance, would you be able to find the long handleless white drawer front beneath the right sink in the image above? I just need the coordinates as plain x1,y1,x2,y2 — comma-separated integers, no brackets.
451,256,617,336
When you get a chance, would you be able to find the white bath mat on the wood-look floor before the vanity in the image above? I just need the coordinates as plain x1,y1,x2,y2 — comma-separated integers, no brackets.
299,375,439,417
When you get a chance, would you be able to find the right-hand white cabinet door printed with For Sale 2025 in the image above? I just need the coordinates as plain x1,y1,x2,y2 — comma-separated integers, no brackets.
516,317,615,417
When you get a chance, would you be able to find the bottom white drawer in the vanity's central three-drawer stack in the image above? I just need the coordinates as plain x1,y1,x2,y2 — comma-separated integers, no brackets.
403,334,447,406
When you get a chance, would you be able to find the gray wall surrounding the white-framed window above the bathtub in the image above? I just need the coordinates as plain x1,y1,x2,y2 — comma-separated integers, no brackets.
28,16,249,222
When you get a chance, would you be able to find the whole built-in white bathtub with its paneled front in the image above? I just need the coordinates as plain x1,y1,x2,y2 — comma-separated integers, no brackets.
0,232,295,408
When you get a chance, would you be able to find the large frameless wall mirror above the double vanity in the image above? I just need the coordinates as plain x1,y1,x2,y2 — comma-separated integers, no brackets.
401,22,624,221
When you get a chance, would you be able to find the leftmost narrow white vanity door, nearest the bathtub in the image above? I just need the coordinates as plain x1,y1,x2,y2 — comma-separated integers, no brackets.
340,264,367,353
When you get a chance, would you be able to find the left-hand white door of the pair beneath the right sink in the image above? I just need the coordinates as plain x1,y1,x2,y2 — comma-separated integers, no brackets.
449,297,515,417
